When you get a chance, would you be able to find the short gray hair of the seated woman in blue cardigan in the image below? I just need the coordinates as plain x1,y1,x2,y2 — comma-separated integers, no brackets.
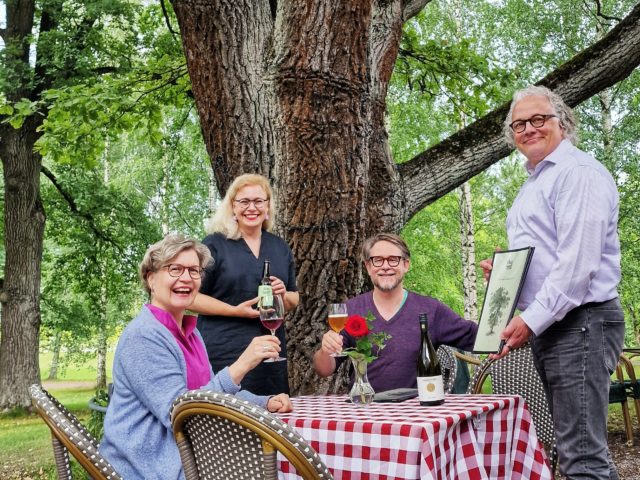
140,233,213,294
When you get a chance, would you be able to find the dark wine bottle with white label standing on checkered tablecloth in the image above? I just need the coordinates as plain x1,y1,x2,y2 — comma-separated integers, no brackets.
418,313,444,405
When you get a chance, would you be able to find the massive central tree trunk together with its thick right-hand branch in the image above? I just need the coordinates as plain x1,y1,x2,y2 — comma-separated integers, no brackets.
172,0,640,393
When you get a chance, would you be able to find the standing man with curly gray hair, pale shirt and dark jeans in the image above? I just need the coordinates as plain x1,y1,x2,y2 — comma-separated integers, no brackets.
480,87,624,479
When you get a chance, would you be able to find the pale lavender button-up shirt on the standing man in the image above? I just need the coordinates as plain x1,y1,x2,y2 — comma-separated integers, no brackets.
507,140,620,335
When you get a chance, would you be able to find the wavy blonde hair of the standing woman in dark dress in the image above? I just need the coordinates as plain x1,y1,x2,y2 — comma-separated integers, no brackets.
207,173,276,240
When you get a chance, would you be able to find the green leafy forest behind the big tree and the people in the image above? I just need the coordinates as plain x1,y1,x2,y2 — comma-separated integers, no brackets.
0,0,640,407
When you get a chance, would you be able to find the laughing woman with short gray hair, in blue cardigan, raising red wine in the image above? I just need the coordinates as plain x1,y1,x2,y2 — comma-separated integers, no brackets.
100,234,291,479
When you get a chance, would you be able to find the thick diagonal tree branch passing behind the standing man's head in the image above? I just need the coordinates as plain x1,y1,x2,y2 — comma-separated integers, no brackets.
398,4,640,219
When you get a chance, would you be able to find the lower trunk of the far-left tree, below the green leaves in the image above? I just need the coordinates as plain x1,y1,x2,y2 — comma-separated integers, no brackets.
0,118,45,410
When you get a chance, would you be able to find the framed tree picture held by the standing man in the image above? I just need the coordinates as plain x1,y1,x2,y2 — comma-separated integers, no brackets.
473,247,534,353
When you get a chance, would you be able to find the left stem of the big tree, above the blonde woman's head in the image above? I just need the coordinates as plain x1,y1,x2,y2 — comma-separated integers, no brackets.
172,0,275,193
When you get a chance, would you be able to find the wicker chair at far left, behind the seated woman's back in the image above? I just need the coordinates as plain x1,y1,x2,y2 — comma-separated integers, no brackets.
29,384,122,480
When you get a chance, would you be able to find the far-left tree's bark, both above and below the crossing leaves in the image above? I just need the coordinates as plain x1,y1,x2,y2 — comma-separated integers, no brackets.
0,0,56,410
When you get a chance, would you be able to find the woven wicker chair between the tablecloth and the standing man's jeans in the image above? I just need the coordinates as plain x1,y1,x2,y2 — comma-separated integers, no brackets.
467,343,557,472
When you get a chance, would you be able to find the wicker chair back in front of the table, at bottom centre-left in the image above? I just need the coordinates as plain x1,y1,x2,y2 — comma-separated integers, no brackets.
171,390,333,480
